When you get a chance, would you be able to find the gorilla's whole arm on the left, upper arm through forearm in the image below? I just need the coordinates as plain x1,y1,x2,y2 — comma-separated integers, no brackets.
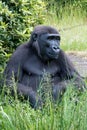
4,54,42,108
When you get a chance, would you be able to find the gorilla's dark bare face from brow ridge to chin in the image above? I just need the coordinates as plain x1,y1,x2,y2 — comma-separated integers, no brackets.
34,33,60,60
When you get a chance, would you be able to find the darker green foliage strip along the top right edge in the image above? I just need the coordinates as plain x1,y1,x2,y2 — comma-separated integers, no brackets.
45,0,87,20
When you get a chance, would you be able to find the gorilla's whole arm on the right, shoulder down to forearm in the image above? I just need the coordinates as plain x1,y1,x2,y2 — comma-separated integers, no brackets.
52,51,86,100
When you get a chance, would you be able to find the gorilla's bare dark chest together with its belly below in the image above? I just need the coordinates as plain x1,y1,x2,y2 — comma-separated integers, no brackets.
22,58,59,89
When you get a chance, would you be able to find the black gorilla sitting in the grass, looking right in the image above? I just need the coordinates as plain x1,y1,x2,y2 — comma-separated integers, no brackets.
4,26,85,108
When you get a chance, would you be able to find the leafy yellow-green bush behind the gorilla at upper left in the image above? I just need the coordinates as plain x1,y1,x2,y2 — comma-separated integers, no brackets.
0,0,45,70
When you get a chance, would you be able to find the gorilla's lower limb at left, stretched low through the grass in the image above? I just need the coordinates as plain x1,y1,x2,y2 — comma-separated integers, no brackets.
5,80,42,109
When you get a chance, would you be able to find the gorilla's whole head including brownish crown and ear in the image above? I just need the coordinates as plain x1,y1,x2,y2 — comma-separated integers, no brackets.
31,26,60,60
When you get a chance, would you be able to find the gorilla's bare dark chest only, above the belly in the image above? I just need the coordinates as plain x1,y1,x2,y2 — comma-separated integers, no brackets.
24,58,59,76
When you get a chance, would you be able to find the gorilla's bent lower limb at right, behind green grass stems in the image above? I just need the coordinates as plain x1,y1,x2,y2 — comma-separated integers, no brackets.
52,77,87,101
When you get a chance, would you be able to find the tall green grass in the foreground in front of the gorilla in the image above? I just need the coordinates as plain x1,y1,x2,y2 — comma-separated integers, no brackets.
0,85,87,130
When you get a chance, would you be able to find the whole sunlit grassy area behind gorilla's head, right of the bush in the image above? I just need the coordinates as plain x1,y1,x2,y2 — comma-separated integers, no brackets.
45,3,87,51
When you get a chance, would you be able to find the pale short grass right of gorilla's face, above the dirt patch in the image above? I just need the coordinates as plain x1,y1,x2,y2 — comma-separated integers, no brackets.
60,24,87,51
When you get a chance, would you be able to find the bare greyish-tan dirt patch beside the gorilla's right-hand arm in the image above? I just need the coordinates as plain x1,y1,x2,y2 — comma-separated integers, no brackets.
67,51,87,77
